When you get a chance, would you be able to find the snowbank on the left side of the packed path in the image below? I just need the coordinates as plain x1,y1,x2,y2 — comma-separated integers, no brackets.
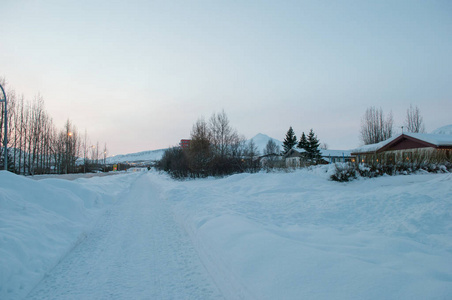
0,171,133,299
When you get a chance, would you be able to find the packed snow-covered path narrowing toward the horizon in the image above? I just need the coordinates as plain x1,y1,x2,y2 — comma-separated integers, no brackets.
27,174,222,299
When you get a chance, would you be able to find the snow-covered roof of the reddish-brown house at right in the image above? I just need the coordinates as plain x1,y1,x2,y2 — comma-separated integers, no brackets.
351,133,452,155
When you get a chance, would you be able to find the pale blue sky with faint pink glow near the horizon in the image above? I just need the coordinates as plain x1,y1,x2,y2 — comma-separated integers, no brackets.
0,0,452,155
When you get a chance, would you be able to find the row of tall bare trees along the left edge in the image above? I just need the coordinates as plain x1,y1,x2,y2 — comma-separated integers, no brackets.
0,78,107,175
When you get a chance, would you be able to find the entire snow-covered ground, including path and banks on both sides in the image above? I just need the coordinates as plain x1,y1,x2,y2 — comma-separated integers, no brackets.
0,166,452,299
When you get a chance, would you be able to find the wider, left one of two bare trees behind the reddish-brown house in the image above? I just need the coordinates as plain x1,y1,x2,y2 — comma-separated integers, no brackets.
361,106,394,145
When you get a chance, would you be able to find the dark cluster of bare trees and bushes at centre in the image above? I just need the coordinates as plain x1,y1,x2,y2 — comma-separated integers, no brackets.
157,111,259,178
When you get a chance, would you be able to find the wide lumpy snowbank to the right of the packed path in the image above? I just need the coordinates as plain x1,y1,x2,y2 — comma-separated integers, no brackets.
166,167,452,299
